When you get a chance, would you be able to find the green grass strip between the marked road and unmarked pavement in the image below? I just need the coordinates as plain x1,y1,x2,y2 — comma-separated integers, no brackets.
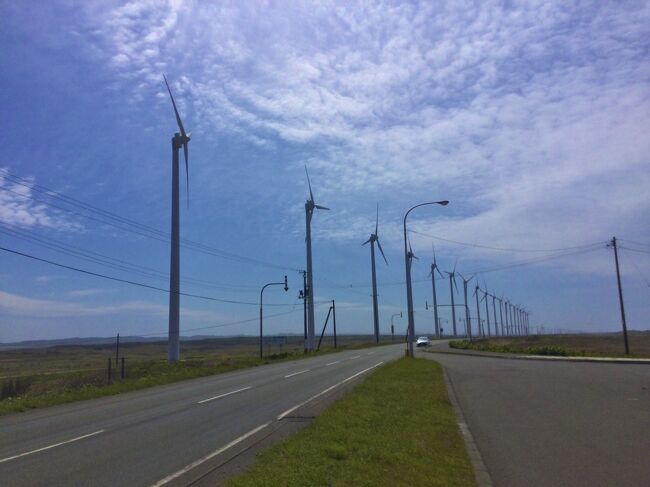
227,359,475,487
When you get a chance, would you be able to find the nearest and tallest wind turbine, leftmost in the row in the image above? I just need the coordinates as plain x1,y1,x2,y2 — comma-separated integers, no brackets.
163,74,190,362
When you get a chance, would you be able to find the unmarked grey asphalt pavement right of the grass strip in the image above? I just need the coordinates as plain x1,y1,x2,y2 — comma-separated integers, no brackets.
426,344,650,487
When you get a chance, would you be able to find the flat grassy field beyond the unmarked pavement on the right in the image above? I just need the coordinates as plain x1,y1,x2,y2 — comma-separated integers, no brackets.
449,331,650,358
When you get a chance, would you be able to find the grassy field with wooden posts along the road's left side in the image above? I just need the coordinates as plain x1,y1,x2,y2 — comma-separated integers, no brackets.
0,336,388,415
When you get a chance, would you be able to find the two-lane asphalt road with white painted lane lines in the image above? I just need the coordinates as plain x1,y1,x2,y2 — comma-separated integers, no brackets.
0,344,404,486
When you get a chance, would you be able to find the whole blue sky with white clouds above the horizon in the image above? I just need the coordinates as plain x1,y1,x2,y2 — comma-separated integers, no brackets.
0,0,650,342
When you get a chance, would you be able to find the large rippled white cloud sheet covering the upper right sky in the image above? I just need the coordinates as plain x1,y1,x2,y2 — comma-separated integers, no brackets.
78,2,650,260
